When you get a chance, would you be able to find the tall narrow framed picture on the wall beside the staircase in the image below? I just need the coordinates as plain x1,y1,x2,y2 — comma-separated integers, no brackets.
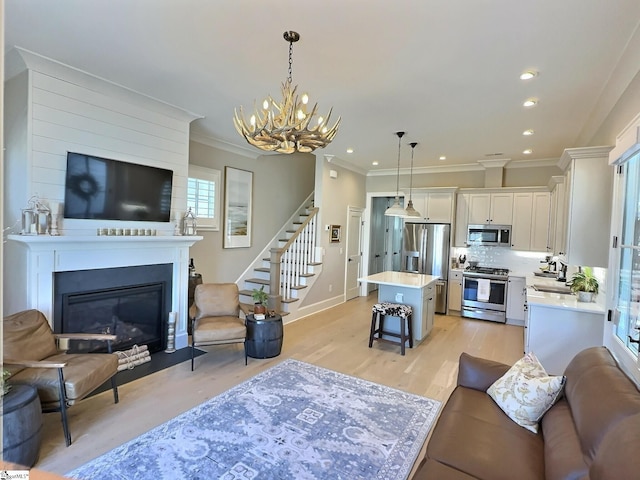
223,167,253,248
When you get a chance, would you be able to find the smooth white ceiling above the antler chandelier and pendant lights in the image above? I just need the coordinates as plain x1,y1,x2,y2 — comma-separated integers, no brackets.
4,0,640,171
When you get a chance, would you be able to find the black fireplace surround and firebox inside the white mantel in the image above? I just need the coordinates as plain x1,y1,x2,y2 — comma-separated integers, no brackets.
53,263,173,353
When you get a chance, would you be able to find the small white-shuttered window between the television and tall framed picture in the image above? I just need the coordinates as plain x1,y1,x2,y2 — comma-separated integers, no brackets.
187,165,220,230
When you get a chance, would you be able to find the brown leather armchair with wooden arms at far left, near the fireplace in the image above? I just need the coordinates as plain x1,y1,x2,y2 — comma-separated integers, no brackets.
2,310,118,447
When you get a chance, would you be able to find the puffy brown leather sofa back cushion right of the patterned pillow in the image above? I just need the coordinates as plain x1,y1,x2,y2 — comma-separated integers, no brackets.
565,347,640,462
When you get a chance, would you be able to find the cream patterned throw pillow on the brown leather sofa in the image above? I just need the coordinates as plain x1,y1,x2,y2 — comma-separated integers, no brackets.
487,352,565,433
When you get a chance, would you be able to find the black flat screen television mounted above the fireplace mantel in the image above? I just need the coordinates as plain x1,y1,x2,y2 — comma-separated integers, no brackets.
64,152,173,222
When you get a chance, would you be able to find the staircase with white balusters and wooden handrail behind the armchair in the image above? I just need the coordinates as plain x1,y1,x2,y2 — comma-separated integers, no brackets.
237,193,322,321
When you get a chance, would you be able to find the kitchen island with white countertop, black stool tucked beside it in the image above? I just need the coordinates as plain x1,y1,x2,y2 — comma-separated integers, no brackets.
358,271,440,345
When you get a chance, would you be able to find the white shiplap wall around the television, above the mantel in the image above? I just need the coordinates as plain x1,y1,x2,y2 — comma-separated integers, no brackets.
4,49,198,235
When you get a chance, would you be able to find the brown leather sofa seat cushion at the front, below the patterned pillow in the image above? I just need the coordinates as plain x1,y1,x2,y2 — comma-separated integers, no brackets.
426,386,544,480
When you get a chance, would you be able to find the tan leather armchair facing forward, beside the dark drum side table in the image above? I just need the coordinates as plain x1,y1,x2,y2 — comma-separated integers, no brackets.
189,283,249,371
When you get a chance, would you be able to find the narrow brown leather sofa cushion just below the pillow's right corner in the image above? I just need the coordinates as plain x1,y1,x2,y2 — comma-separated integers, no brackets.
540,398,589,480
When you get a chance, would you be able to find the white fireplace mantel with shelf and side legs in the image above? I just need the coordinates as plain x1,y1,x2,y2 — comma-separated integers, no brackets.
3,235,202,348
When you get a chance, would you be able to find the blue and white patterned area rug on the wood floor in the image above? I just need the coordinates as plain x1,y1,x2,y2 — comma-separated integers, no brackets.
67,359,440,480
